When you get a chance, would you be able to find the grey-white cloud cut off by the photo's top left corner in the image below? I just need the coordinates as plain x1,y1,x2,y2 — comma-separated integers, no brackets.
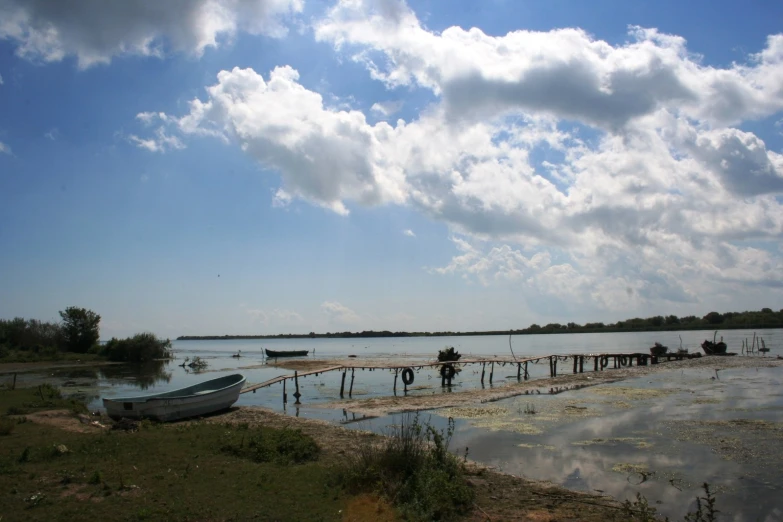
0,0,303,68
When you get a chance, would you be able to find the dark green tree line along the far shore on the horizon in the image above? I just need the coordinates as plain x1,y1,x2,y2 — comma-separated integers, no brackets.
177,308,783,341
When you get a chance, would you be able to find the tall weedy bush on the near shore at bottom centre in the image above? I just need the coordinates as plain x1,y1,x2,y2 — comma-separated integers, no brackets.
341,414,475,520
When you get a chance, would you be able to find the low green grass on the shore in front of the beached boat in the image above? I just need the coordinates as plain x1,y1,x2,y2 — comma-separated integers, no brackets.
0,388,347,522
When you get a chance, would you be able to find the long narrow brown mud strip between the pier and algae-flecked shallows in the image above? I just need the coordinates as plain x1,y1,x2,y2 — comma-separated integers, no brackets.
314,356,783,416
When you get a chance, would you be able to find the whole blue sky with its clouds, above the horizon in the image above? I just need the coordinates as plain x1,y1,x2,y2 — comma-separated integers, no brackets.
0,0,783,337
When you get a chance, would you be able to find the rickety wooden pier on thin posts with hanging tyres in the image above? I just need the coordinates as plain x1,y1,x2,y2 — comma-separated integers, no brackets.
240,352,701,404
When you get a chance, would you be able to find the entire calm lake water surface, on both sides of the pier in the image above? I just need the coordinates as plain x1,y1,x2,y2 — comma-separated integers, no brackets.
7,329,783,521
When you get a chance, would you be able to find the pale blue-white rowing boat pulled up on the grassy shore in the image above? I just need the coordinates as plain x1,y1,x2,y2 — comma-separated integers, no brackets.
103,373,245,422
